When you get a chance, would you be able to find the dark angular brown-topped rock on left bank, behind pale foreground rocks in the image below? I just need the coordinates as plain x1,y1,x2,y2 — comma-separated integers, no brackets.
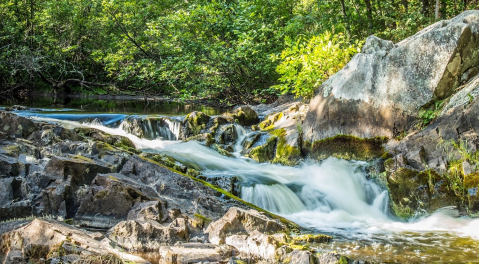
74,173,158,228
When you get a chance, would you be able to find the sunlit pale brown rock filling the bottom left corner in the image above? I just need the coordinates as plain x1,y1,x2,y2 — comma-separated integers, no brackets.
0,219,147,263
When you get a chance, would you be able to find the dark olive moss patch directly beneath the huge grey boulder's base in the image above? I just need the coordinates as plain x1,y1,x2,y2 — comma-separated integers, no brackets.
304,135,387,160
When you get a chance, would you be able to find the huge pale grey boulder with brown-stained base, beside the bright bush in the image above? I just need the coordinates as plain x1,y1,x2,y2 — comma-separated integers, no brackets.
303,10,479,142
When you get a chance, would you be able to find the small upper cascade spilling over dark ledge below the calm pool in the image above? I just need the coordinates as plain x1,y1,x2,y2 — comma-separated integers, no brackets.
119,116,181,140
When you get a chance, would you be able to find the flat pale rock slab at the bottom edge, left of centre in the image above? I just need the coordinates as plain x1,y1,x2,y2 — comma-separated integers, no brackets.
159,243,235,264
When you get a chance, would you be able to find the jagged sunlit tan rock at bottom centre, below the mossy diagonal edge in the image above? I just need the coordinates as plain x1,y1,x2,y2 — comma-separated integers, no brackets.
205,207,286,244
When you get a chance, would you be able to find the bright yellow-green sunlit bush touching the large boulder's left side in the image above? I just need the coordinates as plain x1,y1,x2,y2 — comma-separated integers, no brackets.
273,32,361,98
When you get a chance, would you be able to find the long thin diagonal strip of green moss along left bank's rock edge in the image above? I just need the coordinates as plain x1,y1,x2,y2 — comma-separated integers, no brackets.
140,156,299,232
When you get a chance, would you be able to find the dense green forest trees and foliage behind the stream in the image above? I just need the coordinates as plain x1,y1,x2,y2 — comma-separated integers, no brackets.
0,0,478,104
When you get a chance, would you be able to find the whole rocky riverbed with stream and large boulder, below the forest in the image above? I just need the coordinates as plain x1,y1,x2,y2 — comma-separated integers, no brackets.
0,11,479,263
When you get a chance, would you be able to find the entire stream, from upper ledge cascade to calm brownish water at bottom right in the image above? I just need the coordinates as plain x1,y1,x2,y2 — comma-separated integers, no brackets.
3,103,479,263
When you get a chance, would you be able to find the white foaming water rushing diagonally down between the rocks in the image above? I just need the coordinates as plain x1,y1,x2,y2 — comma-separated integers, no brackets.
28,115,479,260
